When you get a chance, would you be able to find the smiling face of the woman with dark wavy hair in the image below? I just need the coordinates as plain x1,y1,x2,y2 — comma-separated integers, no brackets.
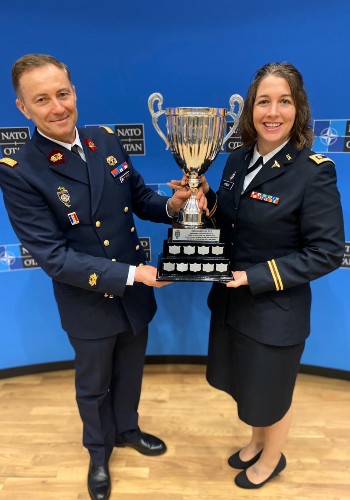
253,75,296,156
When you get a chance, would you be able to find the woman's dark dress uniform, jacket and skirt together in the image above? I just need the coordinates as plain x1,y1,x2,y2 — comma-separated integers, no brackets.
207,141,344,426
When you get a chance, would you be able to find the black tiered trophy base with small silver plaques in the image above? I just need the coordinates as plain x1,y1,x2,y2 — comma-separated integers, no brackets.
157,227,232,282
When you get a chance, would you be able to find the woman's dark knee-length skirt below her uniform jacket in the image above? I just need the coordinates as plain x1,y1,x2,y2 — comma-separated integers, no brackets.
207,321,305,427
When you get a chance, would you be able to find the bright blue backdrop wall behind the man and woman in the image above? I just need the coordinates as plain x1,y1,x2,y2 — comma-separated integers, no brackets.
0,0,350,370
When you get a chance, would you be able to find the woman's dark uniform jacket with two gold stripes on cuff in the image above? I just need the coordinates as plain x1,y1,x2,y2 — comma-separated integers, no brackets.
207,142,344,346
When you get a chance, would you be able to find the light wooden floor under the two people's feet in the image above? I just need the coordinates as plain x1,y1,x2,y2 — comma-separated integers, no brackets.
0,365,350,500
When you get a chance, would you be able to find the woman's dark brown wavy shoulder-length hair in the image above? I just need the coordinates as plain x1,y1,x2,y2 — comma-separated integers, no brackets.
238,62,314,150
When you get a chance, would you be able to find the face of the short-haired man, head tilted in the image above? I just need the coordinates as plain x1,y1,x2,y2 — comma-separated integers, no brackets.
16,64,78,144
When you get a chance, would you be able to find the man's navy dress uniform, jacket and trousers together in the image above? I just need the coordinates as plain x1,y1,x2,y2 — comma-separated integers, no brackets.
0,127,170,465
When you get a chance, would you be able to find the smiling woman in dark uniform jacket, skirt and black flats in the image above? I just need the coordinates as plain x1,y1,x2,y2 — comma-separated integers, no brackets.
205,63,344,488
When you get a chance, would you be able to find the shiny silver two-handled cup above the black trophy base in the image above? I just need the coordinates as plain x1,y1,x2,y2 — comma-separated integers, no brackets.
148,92,243,228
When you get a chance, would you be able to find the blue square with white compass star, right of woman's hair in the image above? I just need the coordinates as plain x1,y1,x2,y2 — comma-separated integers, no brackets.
313,120,350,153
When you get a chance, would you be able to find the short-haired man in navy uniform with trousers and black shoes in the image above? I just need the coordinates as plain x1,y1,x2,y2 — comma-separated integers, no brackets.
0,54,206,500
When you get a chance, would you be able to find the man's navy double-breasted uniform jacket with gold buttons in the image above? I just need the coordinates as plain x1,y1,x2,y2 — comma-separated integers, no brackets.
0,127,170,339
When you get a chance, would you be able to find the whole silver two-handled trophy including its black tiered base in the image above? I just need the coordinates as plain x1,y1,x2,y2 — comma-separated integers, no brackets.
148,93,243,281
